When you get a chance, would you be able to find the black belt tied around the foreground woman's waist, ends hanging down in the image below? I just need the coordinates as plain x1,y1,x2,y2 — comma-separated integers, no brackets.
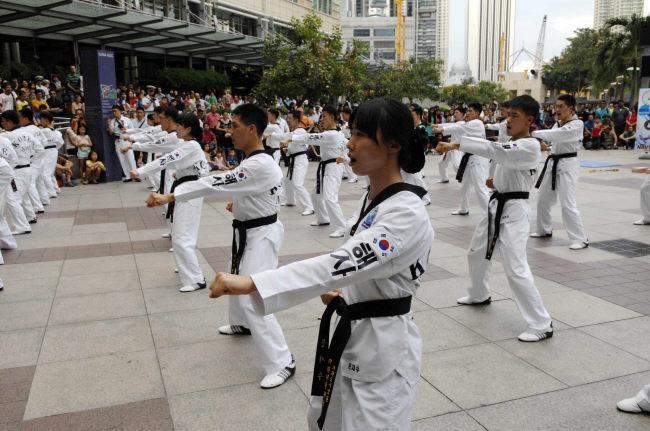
311,296,411,429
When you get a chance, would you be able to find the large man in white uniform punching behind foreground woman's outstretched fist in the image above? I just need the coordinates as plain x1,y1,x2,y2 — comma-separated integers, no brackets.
147,103,296,389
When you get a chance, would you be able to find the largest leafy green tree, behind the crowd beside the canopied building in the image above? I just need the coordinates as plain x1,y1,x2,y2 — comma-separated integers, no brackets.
253,12,366,102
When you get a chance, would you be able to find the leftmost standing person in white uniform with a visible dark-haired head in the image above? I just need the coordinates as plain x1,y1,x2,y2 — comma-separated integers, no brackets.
0,111,45,226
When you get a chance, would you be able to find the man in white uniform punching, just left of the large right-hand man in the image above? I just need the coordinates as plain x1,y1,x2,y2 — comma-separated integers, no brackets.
433,103,490,215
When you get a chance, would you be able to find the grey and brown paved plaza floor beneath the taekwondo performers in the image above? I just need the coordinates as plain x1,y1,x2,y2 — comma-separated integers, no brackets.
0,151,650,431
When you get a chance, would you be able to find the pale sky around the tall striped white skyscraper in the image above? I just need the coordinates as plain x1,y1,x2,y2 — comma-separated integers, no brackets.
449,0,650,71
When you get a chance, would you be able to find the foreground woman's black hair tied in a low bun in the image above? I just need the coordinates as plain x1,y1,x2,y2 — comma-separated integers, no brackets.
350,97,426,174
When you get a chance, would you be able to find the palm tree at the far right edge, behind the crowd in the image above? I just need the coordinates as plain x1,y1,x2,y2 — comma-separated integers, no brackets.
594,14,650,104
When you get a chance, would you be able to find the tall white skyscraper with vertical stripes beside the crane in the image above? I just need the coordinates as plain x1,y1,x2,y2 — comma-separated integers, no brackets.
465,0,515,81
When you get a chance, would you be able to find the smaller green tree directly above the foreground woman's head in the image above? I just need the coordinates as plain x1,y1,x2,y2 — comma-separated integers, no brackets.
367,58,440,101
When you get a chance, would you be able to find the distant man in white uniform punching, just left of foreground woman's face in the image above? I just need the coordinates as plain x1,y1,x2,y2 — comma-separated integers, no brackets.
283,106,347,238
